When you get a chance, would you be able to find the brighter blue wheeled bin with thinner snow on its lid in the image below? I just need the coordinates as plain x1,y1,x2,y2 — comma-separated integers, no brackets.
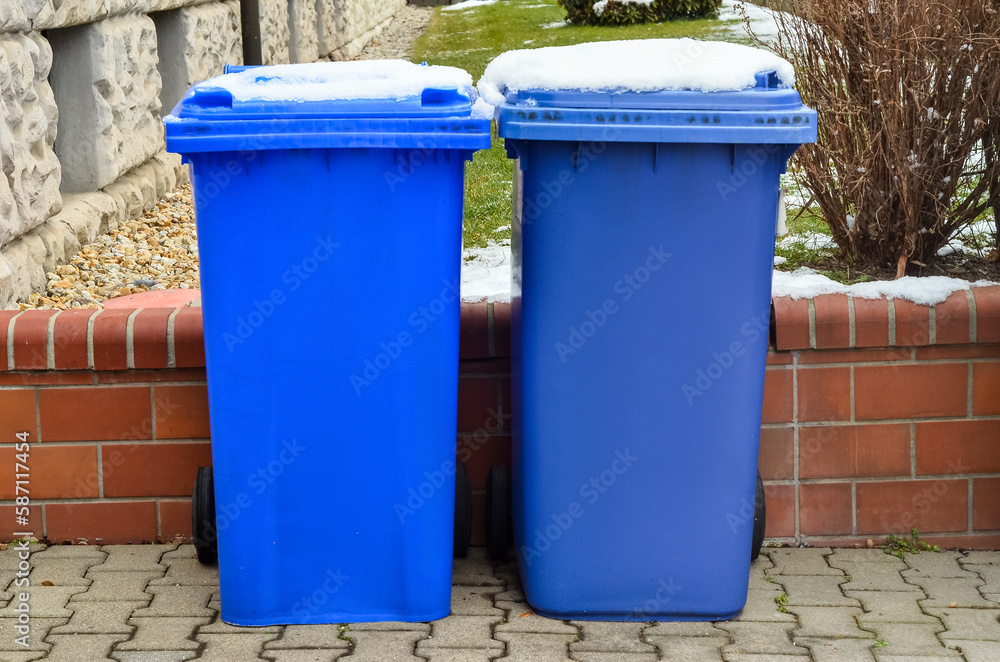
166,62,490,625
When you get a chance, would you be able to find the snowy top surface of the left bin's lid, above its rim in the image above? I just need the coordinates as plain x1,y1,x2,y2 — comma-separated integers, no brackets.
172,60,476,120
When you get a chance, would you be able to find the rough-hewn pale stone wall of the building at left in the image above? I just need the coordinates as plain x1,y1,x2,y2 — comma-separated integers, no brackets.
0,0,406,308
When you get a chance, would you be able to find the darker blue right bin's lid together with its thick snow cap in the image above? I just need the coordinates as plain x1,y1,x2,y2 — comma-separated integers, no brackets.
478,39,816,144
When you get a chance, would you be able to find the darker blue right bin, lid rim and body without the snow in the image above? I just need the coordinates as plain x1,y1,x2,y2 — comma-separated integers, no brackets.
500,78,815,621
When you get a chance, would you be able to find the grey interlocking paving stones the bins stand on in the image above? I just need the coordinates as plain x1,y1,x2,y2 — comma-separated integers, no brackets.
0,545,1000,662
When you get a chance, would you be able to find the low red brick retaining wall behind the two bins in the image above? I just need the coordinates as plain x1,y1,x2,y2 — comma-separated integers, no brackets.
0,286,1000,548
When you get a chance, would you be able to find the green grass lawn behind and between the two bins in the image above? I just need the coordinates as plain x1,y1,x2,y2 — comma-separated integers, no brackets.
412,0,750,247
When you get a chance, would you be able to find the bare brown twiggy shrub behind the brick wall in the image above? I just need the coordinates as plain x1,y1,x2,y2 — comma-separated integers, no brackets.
755,0,1000,275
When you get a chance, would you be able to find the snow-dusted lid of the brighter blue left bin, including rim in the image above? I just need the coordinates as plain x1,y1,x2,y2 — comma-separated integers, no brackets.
164,60,492,153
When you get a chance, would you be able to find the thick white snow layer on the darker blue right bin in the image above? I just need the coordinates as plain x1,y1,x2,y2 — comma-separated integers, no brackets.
478,38,795,105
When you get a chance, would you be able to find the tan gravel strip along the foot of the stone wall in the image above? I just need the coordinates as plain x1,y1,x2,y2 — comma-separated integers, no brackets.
18,5,433,310
